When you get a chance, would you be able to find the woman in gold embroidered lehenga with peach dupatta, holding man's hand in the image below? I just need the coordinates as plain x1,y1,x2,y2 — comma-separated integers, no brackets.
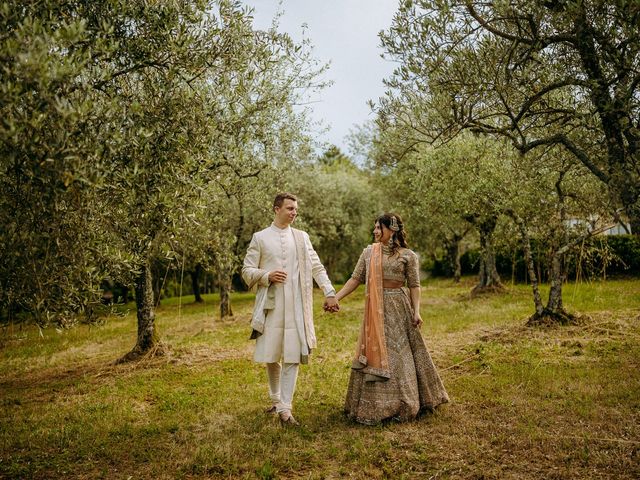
336,213,449,425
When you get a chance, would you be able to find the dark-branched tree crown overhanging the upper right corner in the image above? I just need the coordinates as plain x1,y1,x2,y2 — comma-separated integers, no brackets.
379,0,640,233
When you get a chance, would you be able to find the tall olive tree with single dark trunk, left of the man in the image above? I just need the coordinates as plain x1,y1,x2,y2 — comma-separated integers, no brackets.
100,2,332,356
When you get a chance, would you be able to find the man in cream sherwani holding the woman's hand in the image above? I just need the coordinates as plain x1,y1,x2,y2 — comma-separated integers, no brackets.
242,193,339,425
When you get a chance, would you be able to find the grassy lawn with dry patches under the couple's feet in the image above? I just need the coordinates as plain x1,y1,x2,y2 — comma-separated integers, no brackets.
0,279,640,480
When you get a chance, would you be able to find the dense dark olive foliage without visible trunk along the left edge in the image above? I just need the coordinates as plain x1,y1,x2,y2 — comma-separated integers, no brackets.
0,1,132,325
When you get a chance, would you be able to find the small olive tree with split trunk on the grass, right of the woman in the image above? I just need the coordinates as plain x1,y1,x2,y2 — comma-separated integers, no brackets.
504,148,613,325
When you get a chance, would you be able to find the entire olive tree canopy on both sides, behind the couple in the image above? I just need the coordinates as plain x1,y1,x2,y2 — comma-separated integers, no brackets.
0,0,640,334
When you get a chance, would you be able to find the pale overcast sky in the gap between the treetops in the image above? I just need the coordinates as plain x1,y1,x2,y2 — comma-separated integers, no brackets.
244,0,397,153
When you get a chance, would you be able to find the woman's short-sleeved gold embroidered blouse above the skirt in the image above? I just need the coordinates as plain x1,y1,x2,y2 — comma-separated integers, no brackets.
351,245,420,288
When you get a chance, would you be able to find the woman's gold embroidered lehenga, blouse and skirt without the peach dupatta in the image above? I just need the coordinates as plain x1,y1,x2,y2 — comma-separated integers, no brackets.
345,246,449,425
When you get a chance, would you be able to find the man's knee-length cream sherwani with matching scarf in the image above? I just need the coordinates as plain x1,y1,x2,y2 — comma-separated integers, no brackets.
242,224,335,363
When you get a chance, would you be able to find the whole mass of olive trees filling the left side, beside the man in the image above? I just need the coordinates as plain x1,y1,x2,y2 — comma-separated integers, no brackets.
0,0,340,356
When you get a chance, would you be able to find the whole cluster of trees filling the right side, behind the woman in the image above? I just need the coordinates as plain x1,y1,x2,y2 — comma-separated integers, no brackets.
374,0,640,321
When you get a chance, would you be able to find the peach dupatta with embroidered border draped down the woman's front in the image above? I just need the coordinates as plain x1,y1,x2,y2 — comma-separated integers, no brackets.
351,243,391,382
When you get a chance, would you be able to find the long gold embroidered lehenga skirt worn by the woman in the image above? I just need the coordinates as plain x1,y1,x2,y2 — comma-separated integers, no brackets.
345,289,449,425
